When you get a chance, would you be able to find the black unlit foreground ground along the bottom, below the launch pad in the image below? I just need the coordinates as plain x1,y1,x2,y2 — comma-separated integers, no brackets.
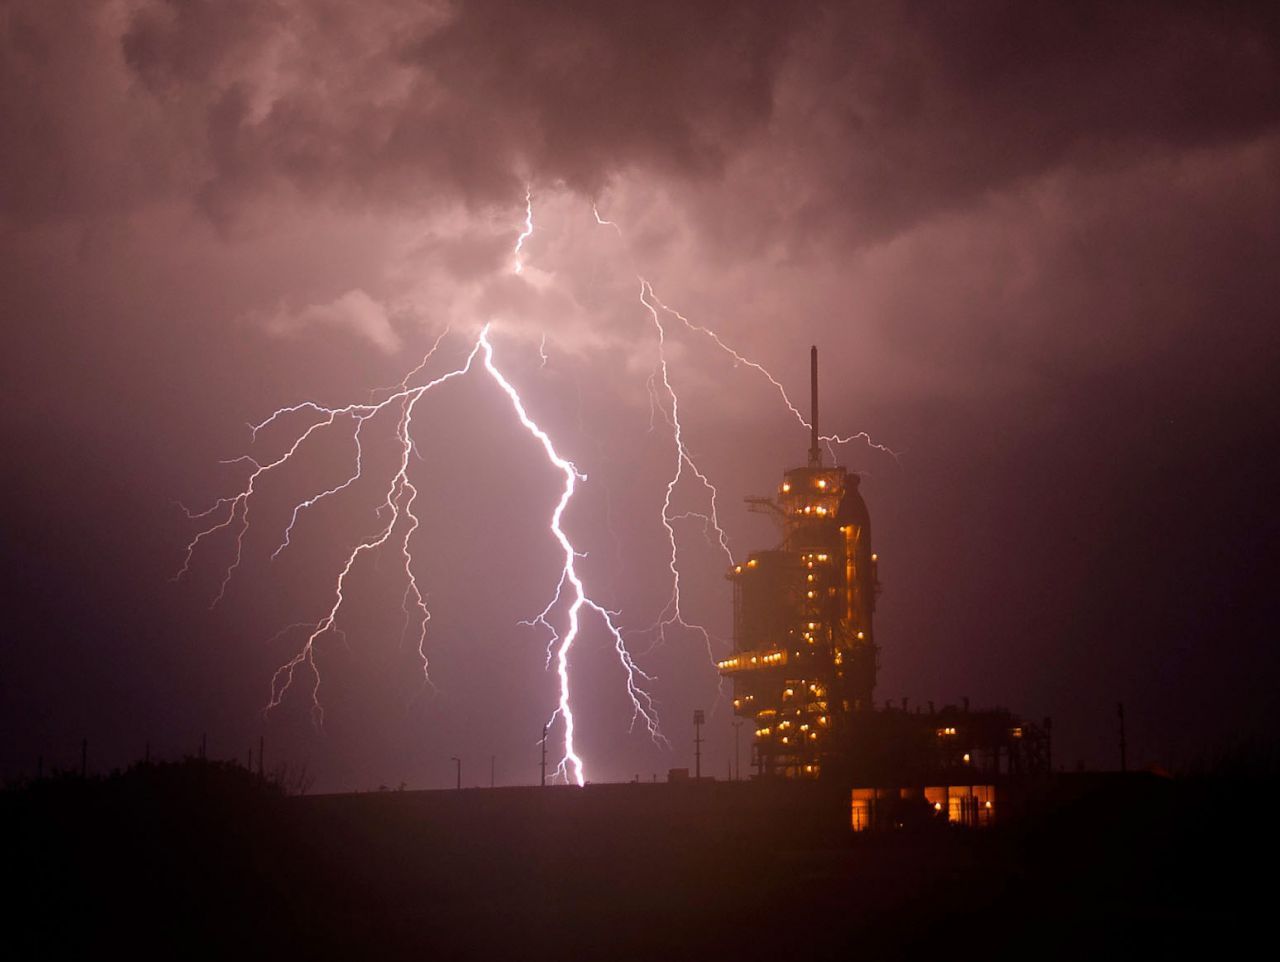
0,760,1277,962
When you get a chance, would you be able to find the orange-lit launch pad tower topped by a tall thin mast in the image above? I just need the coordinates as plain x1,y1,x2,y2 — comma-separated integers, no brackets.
718,348,879,779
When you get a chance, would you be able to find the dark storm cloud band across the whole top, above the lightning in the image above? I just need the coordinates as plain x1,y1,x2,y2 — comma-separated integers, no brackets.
3,0,1280,237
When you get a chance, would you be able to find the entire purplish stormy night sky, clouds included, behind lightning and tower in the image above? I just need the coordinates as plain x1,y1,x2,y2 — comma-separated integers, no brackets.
0,0,1280,791
